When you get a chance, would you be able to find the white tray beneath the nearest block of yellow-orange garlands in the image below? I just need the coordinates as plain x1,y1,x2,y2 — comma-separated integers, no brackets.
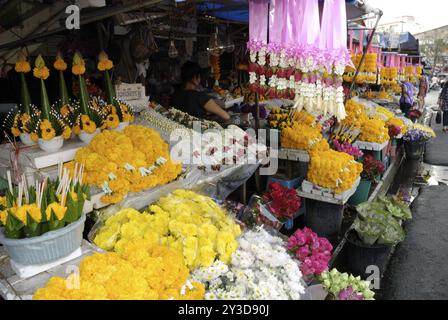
299,178,361,205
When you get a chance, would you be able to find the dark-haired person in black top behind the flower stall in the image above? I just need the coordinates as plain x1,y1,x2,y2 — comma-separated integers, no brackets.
172,61,230,121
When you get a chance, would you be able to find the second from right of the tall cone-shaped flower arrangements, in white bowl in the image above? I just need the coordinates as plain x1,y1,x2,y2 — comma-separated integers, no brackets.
72,52,107,143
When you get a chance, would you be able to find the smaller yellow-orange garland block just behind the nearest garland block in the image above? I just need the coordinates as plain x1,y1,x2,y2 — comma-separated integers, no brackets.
281,122,323,150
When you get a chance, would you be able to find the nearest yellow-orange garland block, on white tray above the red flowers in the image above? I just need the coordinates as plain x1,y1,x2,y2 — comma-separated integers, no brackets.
308,146,363,193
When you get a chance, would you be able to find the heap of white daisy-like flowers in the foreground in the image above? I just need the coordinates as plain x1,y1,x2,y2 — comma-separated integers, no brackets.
192,227,305,300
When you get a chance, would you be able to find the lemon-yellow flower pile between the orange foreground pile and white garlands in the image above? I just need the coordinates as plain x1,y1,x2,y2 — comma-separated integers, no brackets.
94,190,241,270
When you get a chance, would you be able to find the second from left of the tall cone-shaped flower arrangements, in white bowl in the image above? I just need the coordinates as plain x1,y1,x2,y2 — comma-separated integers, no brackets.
31,55,72,152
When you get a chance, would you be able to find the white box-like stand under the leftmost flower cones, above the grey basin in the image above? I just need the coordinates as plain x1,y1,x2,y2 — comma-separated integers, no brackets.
0,139,85,169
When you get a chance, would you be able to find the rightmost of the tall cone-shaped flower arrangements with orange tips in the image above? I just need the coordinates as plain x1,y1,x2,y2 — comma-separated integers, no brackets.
97,51,134,131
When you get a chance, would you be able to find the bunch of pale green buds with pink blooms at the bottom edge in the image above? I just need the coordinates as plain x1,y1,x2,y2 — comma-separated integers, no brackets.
320,269,375,300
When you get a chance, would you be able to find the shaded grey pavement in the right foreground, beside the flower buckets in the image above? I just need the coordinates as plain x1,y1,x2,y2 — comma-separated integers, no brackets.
382,186,448,300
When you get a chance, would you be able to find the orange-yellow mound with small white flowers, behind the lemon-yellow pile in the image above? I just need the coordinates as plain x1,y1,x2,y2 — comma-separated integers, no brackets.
67,125,182,204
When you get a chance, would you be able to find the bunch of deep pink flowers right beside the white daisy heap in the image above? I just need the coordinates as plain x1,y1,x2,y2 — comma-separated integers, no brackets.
288,228,333,278
